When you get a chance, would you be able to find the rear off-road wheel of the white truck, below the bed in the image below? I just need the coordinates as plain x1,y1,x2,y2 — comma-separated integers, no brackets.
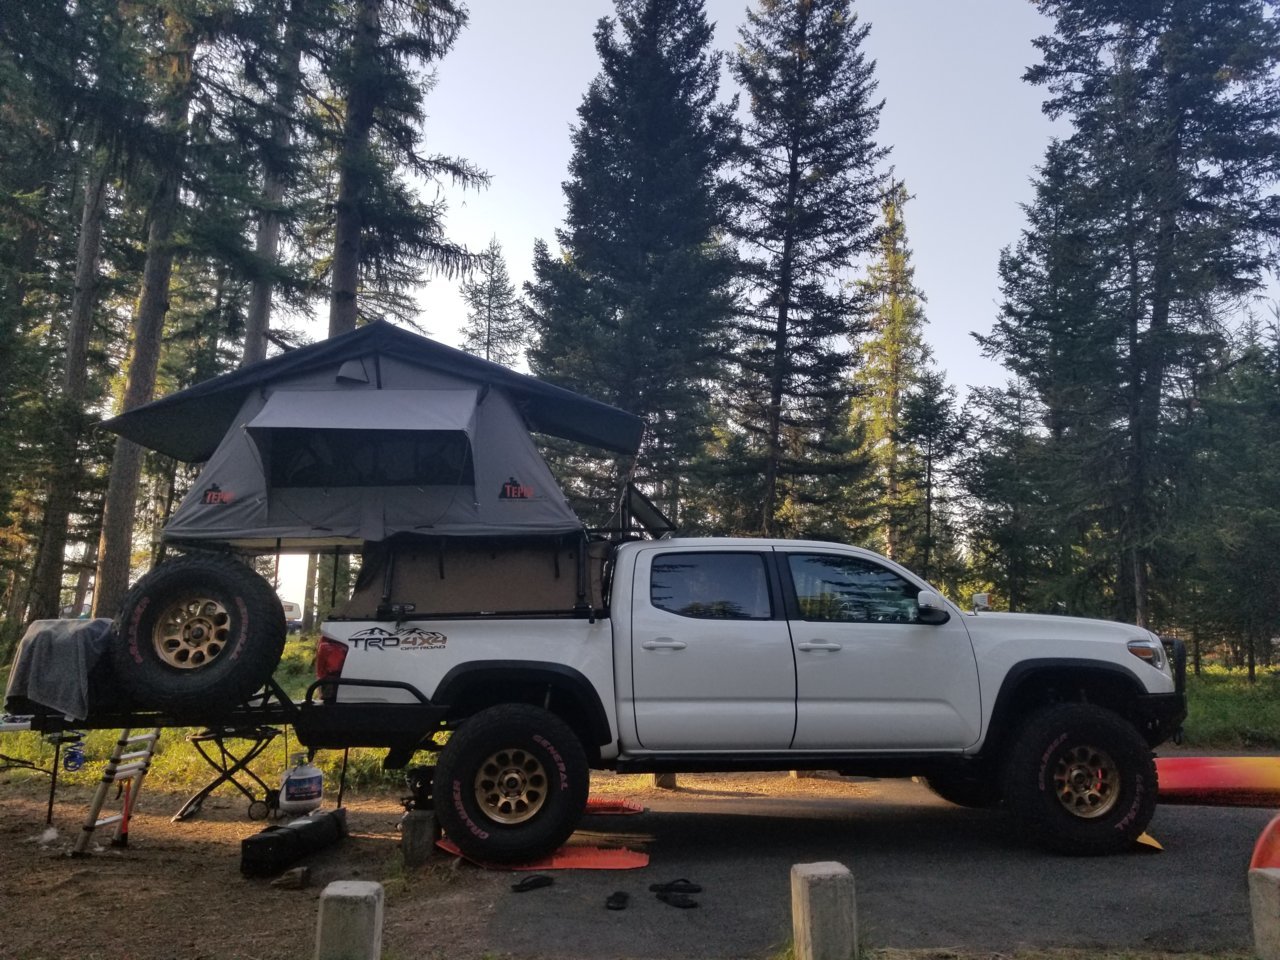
434,704,590,863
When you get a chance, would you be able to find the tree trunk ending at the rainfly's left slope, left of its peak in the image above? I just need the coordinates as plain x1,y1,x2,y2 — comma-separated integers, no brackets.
241,0,305,366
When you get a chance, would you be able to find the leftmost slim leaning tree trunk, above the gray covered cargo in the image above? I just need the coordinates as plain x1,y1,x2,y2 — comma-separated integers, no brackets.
27,164,108,620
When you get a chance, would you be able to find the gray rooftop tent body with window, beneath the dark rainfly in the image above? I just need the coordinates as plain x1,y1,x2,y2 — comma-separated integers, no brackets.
164,357,581,550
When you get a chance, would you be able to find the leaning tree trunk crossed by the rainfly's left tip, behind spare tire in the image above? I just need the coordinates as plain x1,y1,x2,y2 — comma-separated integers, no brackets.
93,28,193,617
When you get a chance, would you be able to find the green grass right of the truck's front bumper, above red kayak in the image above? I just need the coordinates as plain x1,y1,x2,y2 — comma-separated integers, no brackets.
1185,667,1280,750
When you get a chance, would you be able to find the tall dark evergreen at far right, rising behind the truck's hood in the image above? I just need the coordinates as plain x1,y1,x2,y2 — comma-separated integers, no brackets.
970,0,1280,623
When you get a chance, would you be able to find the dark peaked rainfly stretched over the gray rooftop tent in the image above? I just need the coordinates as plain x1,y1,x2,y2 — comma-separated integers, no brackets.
102,320,644,462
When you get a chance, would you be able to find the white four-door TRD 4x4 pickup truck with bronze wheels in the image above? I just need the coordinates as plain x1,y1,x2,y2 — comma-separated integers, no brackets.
317,539,1187,861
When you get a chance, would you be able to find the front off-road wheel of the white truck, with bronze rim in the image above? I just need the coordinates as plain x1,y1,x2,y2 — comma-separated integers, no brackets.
1005,704,1157,856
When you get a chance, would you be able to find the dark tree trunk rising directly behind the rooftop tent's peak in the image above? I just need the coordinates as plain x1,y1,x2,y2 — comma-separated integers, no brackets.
329,0,381,337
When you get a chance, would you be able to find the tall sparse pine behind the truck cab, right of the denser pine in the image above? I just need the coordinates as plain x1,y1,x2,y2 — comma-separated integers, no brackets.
730,0,884,534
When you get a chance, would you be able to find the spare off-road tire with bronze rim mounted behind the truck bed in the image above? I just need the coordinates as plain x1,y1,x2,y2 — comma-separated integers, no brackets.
111,553,285,718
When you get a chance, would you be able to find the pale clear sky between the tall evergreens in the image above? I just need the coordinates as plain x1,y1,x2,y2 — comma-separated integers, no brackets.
409,0,1052,396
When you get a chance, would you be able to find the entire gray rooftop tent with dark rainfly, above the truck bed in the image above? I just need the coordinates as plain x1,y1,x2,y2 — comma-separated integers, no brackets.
104,321,644,550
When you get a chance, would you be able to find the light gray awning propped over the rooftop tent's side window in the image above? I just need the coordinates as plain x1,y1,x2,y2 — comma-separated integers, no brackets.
247,390,476,436
